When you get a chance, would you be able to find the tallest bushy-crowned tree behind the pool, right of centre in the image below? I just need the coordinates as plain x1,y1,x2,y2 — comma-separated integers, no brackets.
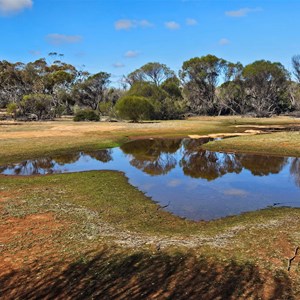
180,55,226,114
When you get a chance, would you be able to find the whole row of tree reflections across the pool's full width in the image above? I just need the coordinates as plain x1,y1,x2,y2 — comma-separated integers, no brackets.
0,139,300,186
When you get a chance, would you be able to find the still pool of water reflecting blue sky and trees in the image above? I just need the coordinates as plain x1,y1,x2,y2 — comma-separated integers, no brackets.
0,139,300,220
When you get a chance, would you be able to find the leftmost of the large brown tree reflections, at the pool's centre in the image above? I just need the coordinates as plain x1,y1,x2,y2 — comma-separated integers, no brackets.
121,139,181,175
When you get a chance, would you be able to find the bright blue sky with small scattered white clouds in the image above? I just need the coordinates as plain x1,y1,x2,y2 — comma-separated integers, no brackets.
0,0,300,82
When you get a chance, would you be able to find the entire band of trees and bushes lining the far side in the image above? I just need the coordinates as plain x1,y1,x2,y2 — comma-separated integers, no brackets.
0,53,300,121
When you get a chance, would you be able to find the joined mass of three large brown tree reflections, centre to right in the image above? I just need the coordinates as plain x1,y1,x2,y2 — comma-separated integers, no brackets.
121,139,290,181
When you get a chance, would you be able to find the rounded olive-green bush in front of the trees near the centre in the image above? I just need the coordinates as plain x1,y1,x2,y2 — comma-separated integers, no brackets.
116,96,154,122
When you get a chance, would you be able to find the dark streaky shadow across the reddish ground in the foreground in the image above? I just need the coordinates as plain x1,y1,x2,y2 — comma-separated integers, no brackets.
0,249,294,299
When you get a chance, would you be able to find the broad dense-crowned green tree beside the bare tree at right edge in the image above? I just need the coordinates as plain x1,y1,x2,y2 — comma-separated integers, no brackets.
242,60,289,117
